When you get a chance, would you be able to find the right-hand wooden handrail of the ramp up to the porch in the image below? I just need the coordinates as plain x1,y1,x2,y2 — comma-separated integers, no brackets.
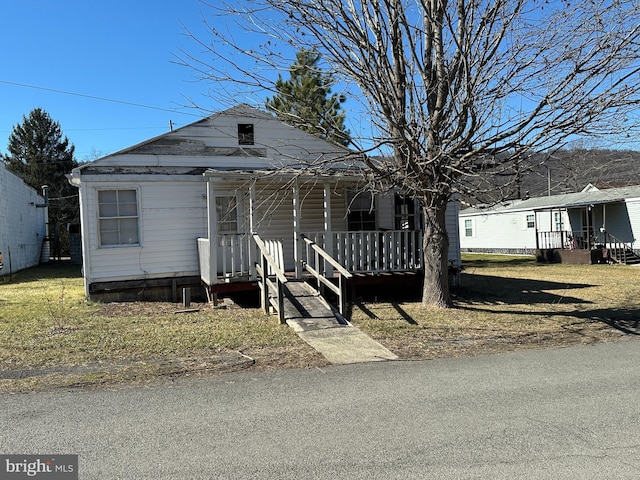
301,235,353,316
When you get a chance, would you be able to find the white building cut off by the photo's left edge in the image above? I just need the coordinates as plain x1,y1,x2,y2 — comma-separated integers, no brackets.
0,162,47,276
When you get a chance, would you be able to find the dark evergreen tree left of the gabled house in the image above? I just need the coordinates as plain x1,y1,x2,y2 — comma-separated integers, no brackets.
0,108,79,255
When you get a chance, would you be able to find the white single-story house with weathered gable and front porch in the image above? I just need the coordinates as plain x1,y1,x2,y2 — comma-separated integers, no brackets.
69,105,460,299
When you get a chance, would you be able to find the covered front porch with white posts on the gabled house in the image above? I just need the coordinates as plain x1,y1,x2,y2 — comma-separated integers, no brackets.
197,171,423,303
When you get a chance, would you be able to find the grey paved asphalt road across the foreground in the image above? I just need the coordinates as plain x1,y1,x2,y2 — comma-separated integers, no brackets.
0,341,640,480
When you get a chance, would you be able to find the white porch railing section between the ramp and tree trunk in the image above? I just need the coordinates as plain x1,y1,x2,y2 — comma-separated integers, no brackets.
303,230,423,273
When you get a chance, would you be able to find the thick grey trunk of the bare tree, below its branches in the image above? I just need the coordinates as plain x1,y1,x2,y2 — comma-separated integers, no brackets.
422,202,453,308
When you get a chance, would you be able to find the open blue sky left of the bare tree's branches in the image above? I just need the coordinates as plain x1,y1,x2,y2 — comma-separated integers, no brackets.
0,0,235,161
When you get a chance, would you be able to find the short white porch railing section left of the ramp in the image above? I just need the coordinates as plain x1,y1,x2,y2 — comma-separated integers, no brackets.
198,233,252,285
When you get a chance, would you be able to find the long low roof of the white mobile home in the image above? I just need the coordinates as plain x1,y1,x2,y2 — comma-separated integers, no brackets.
460,185,640,216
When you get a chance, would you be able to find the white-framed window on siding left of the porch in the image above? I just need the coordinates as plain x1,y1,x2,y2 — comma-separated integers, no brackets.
98,189,140,247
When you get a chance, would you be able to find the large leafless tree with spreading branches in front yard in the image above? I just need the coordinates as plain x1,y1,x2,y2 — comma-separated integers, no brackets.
183,0,640,306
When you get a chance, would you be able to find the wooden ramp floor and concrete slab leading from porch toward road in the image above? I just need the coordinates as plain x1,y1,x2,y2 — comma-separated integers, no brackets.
285,282,398,364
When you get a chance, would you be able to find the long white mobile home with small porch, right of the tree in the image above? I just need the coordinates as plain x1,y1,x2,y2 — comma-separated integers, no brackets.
459,185,640,263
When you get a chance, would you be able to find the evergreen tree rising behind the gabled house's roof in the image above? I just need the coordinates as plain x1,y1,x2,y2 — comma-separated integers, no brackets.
266,49,351,146
